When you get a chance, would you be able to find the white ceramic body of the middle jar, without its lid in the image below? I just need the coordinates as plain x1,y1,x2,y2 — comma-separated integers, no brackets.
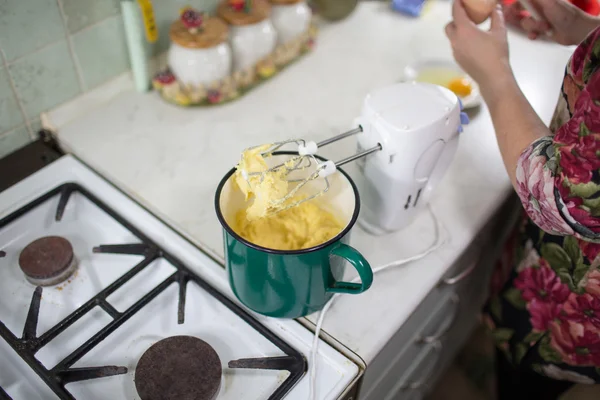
229,19,277,71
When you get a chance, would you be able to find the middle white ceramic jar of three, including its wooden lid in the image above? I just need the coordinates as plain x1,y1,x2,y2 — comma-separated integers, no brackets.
218,0,277,71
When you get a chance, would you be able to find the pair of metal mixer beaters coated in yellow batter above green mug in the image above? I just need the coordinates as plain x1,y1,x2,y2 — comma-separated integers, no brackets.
241,127,382,212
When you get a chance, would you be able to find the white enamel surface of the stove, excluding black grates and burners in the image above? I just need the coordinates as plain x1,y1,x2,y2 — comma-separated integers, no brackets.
0,156,359,400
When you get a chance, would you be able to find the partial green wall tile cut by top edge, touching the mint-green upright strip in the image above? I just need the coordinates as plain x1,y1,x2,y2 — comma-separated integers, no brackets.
59,0,122,33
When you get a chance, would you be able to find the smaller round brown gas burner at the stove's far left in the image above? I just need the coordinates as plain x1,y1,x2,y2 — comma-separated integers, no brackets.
19,236,77,286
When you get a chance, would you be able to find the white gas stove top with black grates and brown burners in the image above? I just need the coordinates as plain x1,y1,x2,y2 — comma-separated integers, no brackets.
0,156,359,400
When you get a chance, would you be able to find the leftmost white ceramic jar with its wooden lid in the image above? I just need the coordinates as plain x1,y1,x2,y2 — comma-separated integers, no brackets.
167,13,232,86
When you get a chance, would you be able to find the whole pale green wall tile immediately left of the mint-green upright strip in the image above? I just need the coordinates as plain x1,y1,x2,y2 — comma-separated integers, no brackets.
73,16,129,89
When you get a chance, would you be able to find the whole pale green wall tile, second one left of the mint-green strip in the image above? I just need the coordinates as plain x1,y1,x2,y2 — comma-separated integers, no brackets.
9,40,80,118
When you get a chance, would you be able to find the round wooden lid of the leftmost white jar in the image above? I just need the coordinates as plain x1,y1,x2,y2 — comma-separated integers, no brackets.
169,11,229,49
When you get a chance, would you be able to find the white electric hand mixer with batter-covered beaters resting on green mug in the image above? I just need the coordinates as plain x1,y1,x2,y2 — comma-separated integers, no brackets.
242,82,468,234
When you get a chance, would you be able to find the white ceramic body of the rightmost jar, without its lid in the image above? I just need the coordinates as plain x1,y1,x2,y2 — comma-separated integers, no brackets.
271,1,312,44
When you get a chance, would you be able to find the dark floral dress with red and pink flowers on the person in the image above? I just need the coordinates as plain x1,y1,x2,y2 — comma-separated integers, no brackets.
486,28,600,384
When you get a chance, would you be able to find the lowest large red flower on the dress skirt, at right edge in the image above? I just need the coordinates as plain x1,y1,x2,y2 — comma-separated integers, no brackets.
550,320,600,367
